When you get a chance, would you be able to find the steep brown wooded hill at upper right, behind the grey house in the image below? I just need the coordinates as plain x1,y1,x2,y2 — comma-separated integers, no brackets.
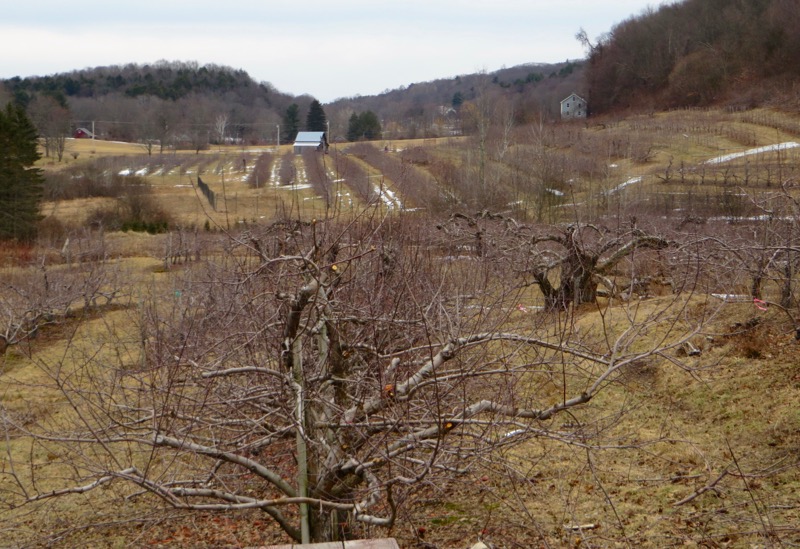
580,0,800,113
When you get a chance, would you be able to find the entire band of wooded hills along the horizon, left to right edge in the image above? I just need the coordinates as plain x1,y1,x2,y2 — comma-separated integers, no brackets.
0,0,800,147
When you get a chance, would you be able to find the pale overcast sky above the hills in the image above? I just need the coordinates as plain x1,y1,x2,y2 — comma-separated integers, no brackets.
0,0,660,103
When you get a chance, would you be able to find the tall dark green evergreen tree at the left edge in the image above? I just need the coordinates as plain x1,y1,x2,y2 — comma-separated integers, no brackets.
0,103,43,241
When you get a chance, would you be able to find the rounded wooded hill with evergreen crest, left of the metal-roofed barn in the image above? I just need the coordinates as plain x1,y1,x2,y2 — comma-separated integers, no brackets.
3,61,312,146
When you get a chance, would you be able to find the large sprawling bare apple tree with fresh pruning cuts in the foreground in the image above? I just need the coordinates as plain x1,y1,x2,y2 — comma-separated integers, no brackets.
2,218,716,542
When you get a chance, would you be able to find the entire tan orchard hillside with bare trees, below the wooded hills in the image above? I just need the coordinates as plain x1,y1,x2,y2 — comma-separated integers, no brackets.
0,109,800,548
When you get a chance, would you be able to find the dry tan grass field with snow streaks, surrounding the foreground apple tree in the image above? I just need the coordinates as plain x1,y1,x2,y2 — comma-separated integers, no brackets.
0,110,800,548
